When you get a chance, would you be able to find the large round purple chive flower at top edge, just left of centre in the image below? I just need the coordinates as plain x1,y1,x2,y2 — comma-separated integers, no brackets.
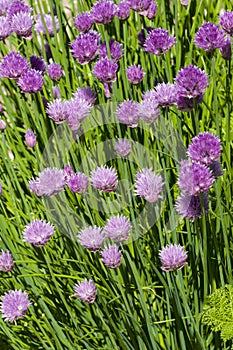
91,0,117,24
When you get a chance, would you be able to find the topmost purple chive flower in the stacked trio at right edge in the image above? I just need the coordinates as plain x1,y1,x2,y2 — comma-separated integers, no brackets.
187,132,221,165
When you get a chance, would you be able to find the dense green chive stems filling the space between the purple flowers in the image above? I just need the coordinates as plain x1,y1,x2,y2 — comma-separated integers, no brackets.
0,0,233,350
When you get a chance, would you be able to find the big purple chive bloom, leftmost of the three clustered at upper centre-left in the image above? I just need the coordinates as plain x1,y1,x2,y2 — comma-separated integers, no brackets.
70,30,100,64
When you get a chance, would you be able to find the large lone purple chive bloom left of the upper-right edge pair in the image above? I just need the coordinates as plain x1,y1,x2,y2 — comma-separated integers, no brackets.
144,28,175,56
